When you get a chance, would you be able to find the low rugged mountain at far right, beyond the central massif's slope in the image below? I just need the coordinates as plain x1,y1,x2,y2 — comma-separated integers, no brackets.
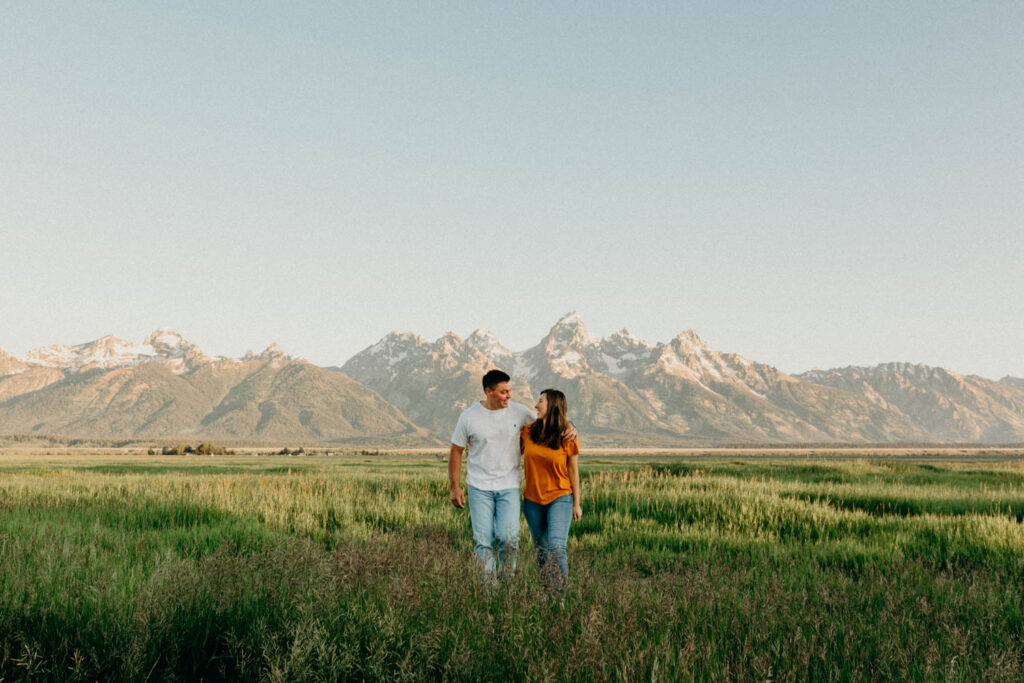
799,362,1024,443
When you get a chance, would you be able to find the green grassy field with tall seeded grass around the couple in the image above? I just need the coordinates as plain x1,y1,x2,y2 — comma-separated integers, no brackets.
0,456,1024,681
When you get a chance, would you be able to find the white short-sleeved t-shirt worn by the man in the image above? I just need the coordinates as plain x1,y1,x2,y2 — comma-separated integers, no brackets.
452,401,535,490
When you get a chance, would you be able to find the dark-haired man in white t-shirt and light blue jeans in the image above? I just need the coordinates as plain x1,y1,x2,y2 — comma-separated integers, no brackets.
449,370,536,583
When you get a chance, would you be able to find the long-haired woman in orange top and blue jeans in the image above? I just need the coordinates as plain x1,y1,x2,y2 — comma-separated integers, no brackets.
520,389,583,592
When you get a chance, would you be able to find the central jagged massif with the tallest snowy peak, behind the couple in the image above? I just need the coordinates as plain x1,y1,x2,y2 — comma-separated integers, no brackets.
342,313,930,445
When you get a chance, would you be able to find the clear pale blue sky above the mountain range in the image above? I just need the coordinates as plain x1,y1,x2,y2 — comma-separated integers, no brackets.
0,2,1024,379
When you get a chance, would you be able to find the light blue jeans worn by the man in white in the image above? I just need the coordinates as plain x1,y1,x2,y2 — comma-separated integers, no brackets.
466,486,519,583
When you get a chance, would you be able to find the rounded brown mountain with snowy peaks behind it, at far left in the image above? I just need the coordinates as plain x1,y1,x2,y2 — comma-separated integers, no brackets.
0,331,433,445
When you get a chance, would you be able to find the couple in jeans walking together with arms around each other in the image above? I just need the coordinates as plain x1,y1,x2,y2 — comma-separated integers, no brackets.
449,370,583,592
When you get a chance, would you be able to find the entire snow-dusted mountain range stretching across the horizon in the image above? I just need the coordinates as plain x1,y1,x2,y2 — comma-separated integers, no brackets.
0,312,1024,446
